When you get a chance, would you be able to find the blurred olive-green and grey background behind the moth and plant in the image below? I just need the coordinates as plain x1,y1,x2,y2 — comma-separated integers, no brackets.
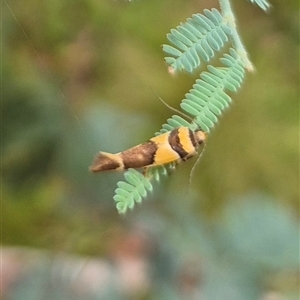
1,0,299,300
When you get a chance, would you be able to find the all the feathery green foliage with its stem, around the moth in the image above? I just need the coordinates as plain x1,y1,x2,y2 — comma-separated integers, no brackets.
114,0,270,213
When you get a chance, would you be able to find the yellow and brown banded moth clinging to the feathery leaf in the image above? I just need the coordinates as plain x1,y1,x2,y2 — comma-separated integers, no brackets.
90,126,207,172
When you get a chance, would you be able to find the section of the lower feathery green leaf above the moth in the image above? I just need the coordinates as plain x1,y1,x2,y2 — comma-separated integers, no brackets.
160,48,245,133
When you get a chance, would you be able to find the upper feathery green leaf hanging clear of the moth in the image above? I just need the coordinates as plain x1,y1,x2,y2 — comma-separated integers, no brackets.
163,8,231,72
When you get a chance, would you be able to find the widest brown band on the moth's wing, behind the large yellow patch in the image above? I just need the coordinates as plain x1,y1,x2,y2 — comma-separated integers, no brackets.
120,141,157,169
